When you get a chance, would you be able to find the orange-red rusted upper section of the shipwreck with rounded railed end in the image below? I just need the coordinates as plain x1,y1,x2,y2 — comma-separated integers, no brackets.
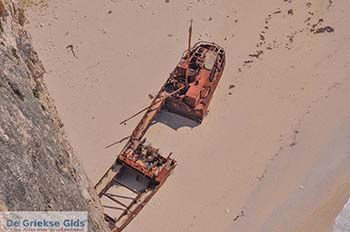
163,42,225,123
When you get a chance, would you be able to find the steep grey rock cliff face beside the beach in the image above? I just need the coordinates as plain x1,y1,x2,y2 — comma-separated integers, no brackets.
0,0,109,231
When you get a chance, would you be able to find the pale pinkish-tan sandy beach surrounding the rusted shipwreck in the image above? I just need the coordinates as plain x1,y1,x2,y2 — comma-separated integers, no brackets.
26,0,350,232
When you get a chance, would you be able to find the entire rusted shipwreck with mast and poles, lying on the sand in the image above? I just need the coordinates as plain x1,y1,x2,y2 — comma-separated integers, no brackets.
95,21,225,232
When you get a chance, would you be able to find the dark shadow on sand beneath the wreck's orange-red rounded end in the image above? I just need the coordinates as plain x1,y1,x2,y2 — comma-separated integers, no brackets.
152,110,199,130
